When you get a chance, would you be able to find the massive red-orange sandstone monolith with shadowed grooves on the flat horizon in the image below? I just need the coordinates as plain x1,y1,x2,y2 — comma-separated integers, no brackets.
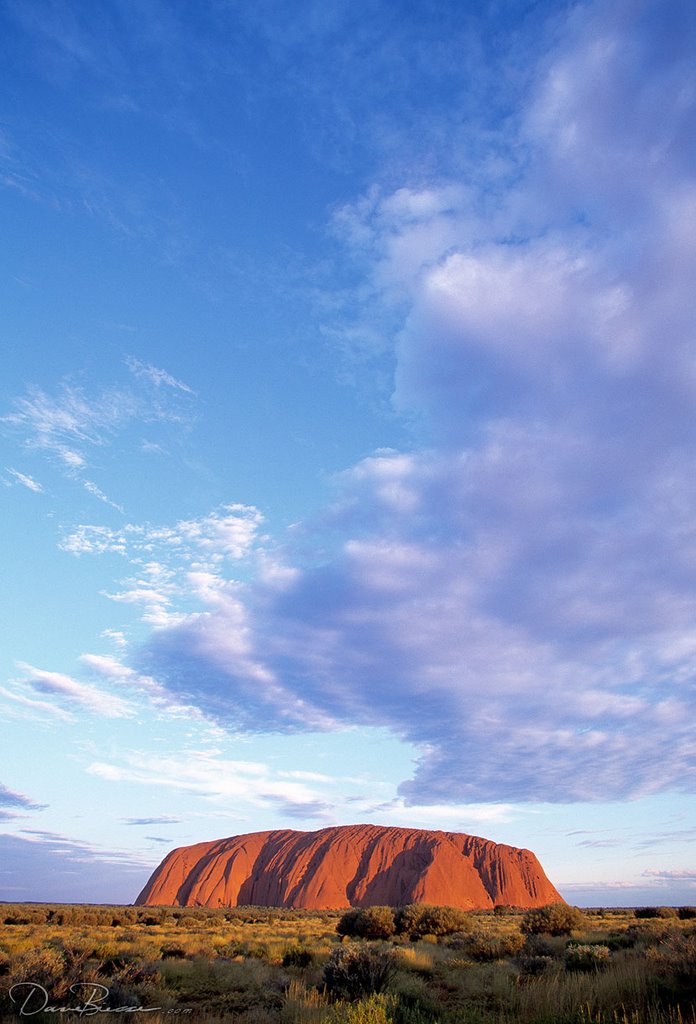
136,825,564,910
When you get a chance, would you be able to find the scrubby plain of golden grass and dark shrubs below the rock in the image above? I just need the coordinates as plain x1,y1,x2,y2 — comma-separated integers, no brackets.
0,904,696,1024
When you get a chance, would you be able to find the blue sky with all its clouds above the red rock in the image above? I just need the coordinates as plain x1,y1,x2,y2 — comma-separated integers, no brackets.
0,0,696,906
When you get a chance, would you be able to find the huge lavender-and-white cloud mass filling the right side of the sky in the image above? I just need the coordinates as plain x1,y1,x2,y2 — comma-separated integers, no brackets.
124,3,696,804
